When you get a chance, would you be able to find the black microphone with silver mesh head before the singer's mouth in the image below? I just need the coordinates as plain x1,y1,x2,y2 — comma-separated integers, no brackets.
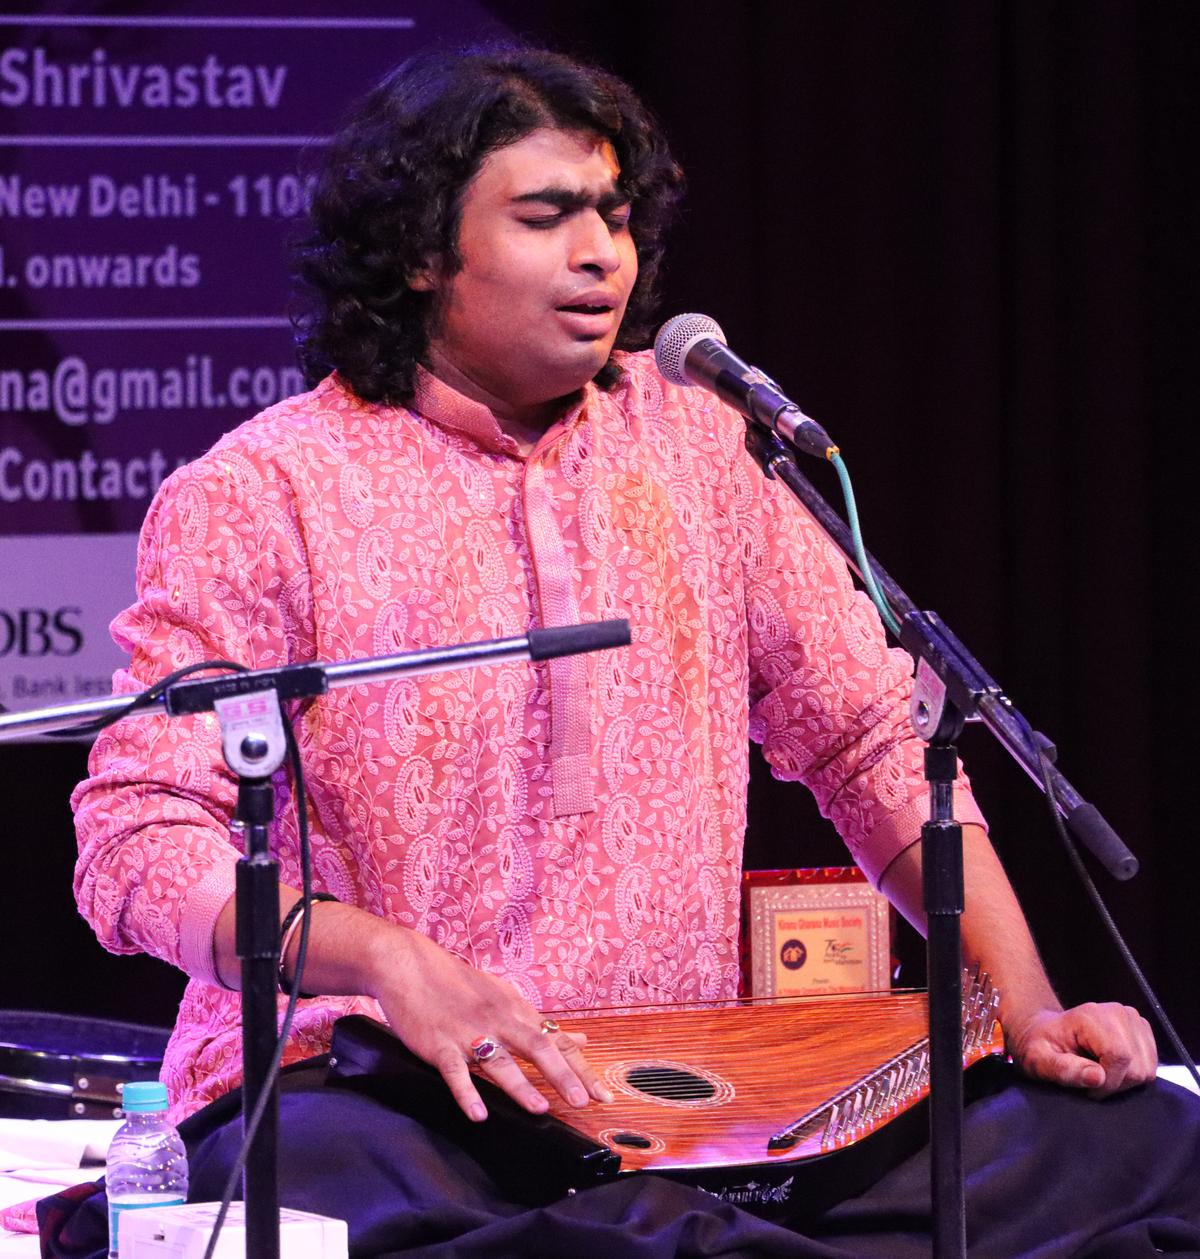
655,315,837,460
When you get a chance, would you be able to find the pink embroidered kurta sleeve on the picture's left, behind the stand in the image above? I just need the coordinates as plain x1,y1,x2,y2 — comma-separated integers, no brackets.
72,448,305,983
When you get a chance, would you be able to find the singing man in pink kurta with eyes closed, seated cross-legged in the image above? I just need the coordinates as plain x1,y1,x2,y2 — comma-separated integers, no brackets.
74,48,1200,1256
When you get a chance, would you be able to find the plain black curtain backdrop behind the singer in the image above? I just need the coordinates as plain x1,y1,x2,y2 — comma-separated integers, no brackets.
0,0,1200,1051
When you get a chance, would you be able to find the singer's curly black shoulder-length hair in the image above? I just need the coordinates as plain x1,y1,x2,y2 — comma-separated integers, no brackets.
293,44,682,404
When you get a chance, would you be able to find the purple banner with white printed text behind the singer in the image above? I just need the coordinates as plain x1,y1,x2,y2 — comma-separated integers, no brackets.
0,0,504,725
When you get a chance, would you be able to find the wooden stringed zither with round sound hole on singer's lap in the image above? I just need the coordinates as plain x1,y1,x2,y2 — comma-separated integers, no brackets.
324,988,1002,1214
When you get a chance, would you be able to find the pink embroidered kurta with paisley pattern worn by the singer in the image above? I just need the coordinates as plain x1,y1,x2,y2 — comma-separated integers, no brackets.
74,354,980,1114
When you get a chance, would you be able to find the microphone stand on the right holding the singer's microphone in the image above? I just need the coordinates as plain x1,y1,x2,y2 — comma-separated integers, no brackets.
745,419,1137,1259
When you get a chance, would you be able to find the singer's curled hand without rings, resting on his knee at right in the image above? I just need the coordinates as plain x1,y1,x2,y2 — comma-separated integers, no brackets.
1005,1001,1158,1098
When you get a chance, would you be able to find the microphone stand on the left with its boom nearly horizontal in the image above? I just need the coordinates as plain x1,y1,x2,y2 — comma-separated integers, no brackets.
0,621,630,1259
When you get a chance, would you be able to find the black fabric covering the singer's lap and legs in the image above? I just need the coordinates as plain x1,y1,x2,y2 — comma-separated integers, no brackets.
39,1066,1200,1259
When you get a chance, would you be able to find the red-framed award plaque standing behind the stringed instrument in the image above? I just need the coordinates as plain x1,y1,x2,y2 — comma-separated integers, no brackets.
742,866,892,997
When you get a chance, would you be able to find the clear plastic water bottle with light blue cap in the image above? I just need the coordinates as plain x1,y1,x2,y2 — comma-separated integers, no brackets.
105,1080,188,1259
